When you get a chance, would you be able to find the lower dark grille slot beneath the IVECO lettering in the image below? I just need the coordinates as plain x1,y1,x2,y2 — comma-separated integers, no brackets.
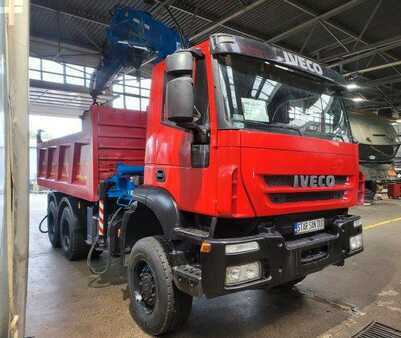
269,191,344,203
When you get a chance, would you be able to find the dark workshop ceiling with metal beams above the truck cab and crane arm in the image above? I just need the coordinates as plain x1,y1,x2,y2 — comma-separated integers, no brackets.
31,0,401,113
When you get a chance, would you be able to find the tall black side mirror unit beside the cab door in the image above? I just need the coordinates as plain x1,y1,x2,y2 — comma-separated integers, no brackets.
166,50,194,124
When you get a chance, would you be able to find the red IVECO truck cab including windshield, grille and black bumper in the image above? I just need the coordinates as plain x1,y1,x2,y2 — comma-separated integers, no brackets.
125,34,363,332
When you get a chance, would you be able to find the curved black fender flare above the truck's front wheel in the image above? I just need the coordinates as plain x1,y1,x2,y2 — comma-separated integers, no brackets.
133,186,181,240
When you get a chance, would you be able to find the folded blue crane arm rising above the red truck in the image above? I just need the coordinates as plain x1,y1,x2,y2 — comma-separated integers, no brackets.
90,6,186,101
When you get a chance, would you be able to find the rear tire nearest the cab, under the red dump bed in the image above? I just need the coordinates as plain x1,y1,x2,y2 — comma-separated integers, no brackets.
60,202,89,261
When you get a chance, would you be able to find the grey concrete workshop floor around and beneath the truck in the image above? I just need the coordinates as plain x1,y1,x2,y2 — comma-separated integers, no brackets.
26,195,401,338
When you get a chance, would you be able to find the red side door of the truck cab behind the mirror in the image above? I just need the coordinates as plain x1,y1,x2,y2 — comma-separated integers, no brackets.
145,58,214,212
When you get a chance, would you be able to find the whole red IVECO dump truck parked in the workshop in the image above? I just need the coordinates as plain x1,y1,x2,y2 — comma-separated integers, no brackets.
38,34,363,335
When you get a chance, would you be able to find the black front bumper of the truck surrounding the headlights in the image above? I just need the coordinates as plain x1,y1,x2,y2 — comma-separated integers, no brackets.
199,216,363,298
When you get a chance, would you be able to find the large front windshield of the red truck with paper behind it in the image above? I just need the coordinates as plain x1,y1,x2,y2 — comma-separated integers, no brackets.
219,55,351,142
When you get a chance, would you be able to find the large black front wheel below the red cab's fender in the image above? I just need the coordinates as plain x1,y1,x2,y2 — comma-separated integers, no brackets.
128,237,192,336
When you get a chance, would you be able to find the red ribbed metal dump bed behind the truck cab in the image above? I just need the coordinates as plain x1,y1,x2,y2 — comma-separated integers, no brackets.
38,105,146,201
